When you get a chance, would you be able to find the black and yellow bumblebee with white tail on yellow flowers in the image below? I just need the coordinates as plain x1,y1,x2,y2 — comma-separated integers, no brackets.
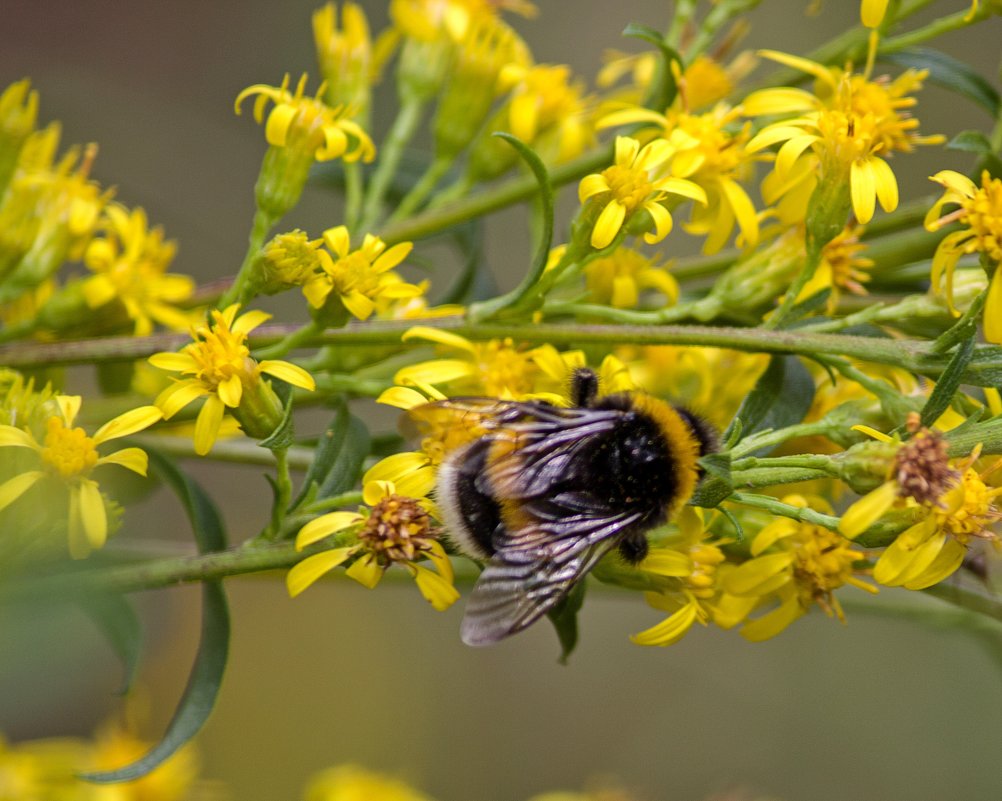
411,369,716,646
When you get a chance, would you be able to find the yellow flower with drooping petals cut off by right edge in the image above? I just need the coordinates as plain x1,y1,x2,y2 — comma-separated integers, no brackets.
926,169,1002,344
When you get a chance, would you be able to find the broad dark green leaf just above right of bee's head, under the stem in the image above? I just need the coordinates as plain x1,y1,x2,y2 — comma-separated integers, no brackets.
722,355,815,441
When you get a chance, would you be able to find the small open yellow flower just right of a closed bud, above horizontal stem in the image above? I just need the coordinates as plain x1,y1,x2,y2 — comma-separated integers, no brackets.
303,226,421,320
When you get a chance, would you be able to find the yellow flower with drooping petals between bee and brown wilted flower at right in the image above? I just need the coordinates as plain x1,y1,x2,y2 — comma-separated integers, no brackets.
723,495,878,642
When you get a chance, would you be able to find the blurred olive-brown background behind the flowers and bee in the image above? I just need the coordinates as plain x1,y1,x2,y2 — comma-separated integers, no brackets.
0,0,1002,801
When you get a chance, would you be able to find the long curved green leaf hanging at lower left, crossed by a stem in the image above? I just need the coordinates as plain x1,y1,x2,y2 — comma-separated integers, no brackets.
80,451,229,784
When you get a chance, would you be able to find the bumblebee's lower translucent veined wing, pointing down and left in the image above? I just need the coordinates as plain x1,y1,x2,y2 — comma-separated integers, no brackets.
461,493,640,646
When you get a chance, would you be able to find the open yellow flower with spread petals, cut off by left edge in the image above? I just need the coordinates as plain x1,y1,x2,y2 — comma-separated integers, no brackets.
0,395,162,559
